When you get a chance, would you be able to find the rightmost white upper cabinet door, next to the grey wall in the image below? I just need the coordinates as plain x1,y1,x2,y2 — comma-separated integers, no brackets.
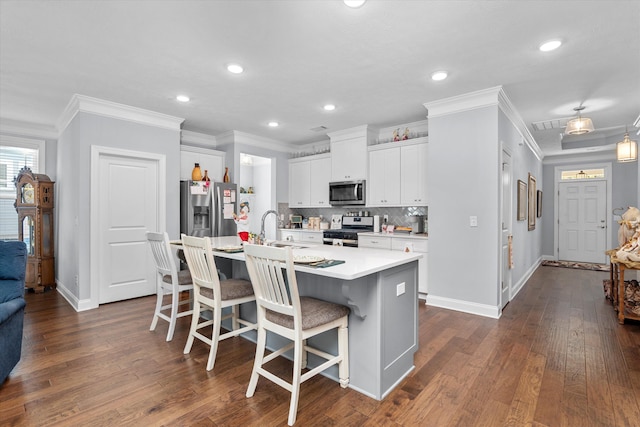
400,144,428,206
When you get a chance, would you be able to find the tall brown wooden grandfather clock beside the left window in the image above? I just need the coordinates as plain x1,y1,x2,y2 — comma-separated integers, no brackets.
15,166,56,292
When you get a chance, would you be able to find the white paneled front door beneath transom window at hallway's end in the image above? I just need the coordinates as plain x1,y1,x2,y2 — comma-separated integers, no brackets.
558,181,607,264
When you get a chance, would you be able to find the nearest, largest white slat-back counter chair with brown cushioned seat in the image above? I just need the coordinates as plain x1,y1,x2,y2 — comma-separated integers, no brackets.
244,245,349,425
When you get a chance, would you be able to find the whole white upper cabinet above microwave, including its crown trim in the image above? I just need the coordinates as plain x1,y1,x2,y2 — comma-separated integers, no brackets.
328,126,374,182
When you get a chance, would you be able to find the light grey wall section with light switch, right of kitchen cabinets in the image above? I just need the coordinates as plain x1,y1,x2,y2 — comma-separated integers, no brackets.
427,105,500,307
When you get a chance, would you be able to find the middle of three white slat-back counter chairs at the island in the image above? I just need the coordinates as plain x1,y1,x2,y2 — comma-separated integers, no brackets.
182,234,256,371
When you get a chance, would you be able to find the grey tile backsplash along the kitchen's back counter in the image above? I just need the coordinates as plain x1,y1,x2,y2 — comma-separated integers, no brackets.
278,203,429,227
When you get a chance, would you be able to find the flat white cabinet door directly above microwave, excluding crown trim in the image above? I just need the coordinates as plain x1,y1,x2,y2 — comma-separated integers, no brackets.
331,137,367,181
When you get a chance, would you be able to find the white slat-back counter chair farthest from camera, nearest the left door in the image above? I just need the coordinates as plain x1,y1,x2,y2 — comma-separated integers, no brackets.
146,231,193,341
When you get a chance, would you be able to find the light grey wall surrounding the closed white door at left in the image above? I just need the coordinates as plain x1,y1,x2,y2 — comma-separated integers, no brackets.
56,112,180,308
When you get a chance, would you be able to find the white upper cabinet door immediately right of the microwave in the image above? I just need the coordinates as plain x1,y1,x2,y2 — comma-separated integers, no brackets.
367,147,400,206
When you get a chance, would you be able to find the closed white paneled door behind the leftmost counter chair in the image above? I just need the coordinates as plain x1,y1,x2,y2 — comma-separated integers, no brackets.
96,153,160,304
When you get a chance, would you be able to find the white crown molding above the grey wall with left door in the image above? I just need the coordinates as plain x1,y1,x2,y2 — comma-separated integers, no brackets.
56,93,184,133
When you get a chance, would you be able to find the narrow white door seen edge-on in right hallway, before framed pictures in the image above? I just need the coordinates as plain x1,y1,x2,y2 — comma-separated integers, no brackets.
500,151,513,308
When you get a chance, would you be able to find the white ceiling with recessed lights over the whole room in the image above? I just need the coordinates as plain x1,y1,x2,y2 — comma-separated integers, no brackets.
0,0,640,155
